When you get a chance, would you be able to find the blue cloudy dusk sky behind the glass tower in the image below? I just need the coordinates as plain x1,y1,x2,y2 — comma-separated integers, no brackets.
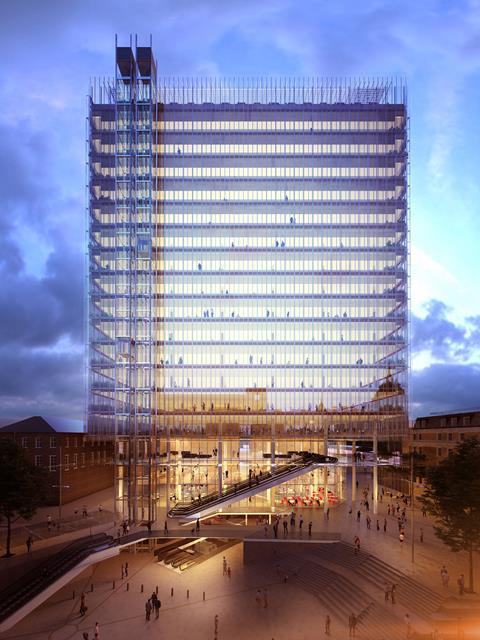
0,0,480,418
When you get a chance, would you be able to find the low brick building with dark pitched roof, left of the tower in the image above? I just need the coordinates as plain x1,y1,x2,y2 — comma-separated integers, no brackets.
0,416,113,505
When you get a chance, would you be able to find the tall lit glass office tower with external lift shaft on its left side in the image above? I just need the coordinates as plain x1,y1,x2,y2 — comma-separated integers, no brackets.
87,46,408,520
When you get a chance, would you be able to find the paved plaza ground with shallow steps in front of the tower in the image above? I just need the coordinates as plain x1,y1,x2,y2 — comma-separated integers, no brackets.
0,477,480,640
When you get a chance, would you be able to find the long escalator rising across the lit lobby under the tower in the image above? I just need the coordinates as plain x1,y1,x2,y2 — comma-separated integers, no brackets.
168,451,338,519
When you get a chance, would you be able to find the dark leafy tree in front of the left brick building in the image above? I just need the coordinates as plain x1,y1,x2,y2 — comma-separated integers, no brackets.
0,437,49,558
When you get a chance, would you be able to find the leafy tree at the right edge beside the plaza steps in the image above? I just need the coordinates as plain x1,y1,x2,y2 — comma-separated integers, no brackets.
420,438,480,592
